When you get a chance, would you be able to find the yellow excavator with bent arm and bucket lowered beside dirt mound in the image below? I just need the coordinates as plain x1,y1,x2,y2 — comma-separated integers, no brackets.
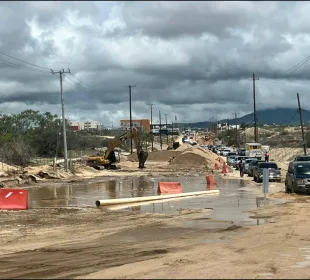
87,127,148,169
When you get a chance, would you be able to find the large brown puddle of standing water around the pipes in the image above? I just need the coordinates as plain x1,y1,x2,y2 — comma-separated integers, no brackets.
24,177,282,227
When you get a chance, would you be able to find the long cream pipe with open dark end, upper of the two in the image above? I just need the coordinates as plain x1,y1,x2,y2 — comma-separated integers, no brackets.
96,190,220,206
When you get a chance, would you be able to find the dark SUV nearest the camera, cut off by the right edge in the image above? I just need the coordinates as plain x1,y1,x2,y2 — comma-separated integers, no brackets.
285,161,310,193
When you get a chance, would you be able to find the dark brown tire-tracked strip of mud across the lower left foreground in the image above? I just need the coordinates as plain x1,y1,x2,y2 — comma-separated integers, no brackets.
0,225,205,279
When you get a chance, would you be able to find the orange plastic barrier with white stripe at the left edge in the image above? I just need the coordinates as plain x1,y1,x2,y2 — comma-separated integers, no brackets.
0,189,28,210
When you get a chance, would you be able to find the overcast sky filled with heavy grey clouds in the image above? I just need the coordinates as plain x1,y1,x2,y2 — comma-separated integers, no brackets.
0,1,310,126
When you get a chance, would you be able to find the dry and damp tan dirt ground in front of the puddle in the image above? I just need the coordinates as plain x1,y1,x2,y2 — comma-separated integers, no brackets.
0,197,310,279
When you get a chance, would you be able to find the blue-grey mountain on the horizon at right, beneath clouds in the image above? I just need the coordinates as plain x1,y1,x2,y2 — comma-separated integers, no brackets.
188,108,310,128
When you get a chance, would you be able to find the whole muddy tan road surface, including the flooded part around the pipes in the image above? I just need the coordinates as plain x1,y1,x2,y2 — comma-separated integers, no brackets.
0,175,310,279
